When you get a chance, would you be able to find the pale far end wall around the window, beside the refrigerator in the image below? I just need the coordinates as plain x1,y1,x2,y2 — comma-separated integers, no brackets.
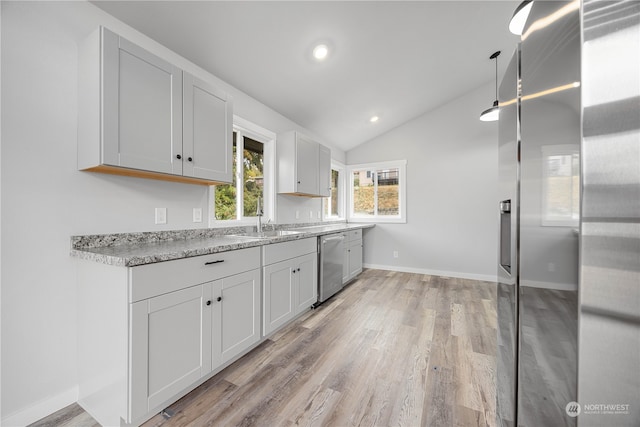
347,84,498,280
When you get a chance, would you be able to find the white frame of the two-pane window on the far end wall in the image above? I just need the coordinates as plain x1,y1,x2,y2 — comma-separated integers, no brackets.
345,160,407,224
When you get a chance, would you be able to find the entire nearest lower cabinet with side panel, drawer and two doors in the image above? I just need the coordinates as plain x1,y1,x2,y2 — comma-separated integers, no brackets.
78,247,262,426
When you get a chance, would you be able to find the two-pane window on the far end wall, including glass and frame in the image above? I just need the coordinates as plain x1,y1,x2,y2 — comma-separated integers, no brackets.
348,160,407,222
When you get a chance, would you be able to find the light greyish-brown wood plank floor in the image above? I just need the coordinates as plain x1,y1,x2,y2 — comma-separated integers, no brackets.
34,270,497,427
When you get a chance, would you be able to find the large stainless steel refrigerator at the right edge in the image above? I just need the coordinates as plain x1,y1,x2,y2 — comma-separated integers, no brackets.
496,0,640,427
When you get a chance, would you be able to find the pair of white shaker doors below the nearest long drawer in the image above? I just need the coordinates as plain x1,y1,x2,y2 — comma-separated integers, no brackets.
130,269,260,419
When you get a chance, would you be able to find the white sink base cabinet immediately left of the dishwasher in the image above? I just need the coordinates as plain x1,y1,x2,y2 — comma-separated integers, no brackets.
262,238,318,336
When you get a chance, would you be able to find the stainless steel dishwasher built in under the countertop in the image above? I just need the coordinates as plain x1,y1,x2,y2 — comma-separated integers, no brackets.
316,233,344,306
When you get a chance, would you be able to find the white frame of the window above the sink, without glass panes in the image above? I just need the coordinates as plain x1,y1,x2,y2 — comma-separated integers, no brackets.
208,114,276,228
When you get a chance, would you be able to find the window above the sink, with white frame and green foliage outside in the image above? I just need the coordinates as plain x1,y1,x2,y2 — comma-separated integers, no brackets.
209,116,275,226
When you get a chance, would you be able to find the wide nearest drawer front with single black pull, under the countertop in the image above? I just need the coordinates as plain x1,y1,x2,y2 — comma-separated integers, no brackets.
129,247,260,302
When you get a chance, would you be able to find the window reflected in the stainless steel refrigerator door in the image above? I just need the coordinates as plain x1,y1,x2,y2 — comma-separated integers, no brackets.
542,145,580,227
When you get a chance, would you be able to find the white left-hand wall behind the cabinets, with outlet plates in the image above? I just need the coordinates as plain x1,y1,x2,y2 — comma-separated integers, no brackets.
0,1,344,425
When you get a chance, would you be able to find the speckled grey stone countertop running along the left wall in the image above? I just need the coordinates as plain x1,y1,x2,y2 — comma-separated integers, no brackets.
71,223,374,267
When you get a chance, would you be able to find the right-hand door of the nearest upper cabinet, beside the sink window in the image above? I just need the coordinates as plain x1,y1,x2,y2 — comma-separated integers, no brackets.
182,72,233,183
